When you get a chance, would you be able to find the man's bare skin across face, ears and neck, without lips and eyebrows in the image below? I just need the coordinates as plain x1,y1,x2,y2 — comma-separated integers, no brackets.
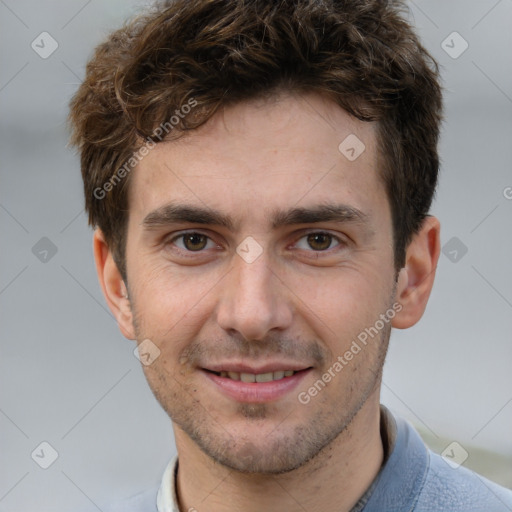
94,95,440,512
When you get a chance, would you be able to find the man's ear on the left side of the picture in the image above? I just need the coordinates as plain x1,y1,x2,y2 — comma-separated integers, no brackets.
93,229,135,340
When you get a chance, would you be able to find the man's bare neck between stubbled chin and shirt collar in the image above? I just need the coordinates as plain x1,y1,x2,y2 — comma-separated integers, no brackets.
175,393,384,512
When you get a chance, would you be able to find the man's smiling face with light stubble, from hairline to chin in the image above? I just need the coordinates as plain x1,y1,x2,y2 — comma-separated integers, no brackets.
126,91,395,473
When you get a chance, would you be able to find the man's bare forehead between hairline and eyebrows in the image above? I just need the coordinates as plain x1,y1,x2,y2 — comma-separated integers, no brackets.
129,95,387,228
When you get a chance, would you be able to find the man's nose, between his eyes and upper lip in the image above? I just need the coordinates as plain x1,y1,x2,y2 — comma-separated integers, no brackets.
217,247,293,341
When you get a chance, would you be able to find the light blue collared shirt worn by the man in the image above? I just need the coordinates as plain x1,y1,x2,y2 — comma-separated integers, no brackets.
103,406,512,512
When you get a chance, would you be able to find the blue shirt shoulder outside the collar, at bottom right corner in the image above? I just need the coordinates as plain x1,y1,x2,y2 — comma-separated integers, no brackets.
414,450,512,512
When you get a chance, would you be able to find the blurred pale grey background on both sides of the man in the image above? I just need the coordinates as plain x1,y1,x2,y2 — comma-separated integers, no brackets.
0,0,512,512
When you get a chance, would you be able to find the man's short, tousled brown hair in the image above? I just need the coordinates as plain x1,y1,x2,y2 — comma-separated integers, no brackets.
70,0,442,278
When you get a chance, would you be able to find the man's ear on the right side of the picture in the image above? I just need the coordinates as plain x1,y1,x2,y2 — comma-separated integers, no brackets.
391,216,441,329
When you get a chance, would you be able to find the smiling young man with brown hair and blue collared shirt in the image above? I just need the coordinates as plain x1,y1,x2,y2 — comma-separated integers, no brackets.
71,0,512,512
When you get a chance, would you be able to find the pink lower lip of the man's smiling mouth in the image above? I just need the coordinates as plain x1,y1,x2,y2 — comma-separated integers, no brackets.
203,368,311,403
